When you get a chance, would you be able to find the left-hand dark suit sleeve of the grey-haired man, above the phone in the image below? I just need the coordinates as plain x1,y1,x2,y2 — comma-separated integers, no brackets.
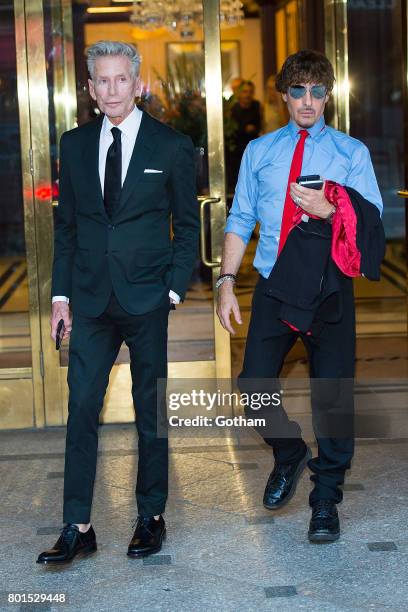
51,134,76,298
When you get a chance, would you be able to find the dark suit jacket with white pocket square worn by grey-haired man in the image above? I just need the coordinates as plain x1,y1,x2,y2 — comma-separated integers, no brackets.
52,112,199,317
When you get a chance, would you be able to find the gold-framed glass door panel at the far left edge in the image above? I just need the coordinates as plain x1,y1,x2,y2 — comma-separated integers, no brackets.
0,0,45,429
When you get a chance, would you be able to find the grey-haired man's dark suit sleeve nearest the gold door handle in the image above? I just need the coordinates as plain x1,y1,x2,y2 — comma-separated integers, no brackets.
170,136,200,300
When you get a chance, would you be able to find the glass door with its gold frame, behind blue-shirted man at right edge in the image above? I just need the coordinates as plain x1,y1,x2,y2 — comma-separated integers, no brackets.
325,0,407,340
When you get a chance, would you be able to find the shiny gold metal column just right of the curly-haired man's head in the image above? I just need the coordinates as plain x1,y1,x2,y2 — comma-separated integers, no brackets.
324,0,350,134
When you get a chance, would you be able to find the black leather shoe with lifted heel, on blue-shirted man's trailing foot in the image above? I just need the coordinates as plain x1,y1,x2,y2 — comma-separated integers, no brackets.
263,446,312,510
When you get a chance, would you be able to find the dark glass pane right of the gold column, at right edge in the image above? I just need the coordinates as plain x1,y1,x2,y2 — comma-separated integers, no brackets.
346,2,407,334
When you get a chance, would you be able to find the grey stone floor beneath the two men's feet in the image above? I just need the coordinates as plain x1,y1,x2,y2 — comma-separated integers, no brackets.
0,425,408,612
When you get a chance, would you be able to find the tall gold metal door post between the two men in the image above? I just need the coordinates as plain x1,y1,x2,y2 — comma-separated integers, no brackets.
203,0,231,378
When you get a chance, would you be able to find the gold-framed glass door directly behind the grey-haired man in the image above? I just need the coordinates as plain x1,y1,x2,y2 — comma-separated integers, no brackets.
29,0,231,424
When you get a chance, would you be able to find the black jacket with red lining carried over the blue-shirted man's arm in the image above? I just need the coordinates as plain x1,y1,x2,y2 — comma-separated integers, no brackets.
264,187,385,332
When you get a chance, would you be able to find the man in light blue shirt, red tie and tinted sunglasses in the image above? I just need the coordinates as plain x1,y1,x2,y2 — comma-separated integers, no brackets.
217,51,382,542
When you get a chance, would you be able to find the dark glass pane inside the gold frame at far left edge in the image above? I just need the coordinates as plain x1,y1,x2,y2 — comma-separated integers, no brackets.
0,2,31,368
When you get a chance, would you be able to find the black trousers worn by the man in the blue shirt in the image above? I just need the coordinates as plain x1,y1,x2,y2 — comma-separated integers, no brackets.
239,275,355,505
